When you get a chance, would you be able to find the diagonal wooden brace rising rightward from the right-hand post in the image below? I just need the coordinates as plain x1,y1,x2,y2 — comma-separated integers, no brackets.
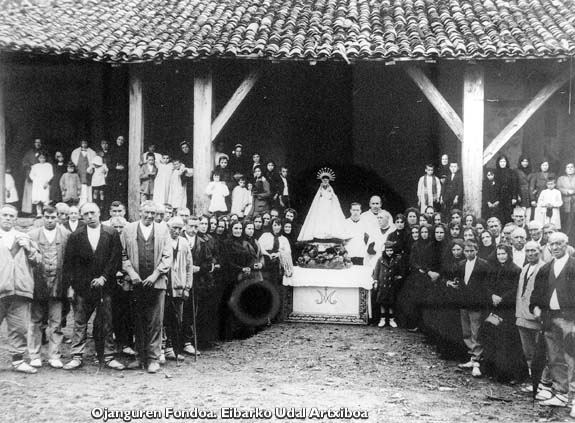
483,70,571,165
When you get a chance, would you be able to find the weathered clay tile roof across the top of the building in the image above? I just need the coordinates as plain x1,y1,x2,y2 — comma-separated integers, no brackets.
0,0,575,63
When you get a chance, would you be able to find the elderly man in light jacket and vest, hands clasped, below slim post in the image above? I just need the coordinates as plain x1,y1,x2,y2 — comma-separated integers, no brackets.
121,200,172,373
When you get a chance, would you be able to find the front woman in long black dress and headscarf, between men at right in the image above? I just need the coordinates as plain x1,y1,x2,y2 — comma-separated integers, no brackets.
480,244,527,382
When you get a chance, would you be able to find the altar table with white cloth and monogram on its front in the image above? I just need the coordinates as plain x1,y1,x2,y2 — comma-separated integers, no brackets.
283,266,373,325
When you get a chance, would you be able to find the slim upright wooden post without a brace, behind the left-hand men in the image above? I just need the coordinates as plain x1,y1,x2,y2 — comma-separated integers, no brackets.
128,69,144,221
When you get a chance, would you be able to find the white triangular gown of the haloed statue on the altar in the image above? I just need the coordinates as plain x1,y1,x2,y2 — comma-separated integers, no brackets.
297,185,350,241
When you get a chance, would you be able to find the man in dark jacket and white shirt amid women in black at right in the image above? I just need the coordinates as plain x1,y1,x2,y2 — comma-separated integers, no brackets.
447,241,490,377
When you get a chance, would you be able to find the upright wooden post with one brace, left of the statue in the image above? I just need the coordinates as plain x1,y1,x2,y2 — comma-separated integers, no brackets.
193,69,214,215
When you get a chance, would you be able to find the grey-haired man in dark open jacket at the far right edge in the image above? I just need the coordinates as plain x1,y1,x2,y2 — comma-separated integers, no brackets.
529,232,575,417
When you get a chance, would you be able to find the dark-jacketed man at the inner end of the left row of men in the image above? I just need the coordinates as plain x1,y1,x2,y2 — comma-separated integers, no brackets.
182,216,217,355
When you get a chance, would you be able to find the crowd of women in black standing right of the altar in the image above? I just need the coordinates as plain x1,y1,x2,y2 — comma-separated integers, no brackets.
390,208,527,381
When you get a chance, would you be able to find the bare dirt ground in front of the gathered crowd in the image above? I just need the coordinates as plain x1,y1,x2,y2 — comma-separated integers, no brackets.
0,323,570,423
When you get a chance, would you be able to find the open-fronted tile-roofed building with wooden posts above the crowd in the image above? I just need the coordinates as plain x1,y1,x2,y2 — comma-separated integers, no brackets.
0,0,575,216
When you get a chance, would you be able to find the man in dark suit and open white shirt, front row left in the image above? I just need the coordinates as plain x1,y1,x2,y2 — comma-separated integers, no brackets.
63,203,124,370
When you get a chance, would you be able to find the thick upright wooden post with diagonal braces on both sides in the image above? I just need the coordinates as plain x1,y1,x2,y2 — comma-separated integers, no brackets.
461,65,485,216
